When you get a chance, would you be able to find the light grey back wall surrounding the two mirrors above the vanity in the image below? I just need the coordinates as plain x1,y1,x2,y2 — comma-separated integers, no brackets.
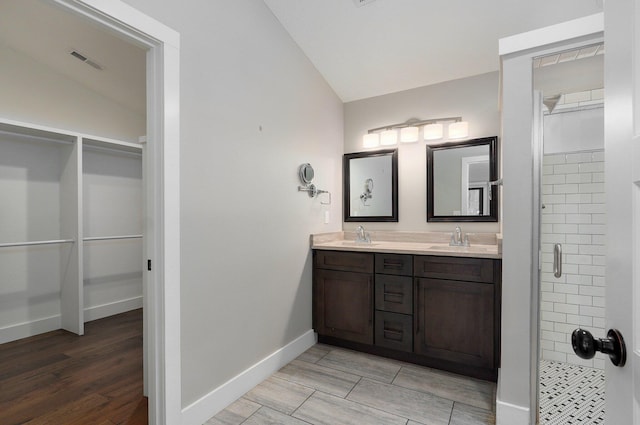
344,72,500,232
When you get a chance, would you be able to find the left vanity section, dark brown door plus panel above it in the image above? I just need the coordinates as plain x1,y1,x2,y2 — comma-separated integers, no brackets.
313,251,374,344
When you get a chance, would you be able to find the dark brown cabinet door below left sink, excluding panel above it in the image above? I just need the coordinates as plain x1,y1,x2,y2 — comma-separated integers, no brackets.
313,269,373,344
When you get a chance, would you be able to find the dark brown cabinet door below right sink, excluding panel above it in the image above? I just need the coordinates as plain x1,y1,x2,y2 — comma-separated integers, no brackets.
414,279,494,367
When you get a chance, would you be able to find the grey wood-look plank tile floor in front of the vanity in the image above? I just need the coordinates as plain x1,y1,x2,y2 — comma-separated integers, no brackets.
205,344,496,425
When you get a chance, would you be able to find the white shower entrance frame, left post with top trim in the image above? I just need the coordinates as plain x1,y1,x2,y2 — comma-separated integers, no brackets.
496,13,604,425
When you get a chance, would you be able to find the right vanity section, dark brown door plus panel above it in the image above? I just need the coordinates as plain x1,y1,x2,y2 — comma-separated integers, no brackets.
414,256,499,369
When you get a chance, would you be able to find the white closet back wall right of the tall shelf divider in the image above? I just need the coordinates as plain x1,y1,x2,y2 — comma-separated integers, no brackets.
82,148,143,321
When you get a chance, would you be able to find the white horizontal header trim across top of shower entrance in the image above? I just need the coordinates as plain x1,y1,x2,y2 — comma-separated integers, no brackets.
498,13,604,56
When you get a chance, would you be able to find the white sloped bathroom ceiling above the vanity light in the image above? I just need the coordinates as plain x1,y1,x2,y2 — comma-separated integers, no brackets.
264,0,602,102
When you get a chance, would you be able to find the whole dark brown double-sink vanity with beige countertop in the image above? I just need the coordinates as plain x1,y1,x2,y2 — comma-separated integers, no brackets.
312,232,501,381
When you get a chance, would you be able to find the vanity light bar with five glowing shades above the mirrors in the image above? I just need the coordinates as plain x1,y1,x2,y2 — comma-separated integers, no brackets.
362,117,469,148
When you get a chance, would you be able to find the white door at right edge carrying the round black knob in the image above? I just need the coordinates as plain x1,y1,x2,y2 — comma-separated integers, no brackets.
598,0,640,425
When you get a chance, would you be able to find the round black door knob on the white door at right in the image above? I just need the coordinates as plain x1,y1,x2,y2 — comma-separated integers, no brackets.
571,329,627,367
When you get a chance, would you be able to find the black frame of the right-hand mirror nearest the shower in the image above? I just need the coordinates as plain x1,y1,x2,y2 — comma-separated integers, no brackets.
427,136,498,222
